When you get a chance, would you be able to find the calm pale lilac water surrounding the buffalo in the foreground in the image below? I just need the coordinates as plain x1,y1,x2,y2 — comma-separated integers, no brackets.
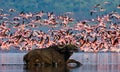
0,53,120,72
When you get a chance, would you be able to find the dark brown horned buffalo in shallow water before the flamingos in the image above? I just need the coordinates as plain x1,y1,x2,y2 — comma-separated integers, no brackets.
23,44,81,68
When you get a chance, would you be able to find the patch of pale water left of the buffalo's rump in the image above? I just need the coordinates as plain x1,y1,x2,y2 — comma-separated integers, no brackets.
0,53,24,72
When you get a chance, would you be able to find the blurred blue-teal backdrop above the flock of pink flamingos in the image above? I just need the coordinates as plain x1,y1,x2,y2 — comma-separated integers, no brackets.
0,0,120,20
